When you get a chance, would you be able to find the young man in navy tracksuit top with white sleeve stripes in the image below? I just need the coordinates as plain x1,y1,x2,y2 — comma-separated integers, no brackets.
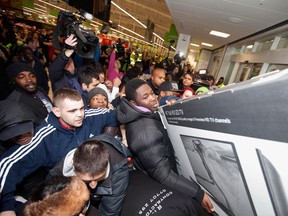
0,89,119,215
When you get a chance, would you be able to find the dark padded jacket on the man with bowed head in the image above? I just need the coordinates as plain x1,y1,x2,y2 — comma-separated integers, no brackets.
49,134,129,216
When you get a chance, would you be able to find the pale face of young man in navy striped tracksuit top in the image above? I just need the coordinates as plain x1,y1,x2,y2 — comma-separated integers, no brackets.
53,99,84,127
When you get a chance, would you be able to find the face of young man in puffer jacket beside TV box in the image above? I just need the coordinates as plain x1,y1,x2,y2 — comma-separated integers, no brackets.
134,84,159,111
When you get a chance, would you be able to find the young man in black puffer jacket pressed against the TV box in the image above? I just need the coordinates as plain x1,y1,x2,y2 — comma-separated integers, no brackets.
117,79,214,215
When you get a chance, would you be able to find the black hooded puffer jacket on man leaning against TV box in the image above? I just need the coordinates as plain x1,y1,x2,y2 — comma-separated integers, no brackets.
117,98,204,204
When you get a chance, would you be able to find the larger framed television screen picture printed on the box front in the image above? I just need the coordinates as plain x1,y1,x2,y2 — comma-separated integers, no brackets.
180,135,255,216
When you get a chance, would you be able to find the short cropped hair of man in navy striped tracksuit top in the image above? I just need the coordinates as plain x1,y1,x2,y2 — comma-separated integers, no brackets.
53,88,82,107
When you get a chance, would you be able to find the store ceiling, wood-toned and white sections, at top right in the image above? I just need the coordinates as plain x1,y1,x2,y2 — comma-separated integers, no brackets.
110,0,288,50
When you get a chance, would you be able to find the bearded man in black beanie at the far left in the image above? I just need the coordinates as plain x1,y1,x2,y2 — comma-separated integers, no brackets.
6,62,52,125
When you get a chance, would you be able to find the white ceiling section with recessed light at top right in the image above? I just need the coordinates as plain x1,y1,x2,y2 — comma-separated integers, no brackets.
166,0,288,49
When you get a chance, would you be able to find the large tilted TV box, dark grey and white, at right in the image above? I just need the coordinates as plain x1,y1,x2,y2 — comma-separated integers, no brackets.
159,69,288,216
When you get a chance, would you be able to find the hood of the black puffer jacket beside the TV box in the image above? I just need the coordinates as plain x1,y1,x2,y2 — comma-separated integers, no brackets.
117,97,157,124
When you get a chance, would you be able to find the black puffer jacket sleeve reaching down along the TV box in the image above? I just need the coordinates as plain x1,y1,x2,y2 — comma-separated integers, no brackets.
128,127,204,203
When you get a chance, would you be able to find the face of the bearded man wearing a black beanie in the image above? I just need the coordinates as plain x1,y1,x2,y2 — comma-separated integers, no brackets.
14,71,37,93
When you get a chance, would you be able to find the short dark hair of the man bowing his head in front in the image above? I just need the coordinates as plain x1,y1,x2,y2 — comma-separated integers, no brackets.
73,140,109,176
